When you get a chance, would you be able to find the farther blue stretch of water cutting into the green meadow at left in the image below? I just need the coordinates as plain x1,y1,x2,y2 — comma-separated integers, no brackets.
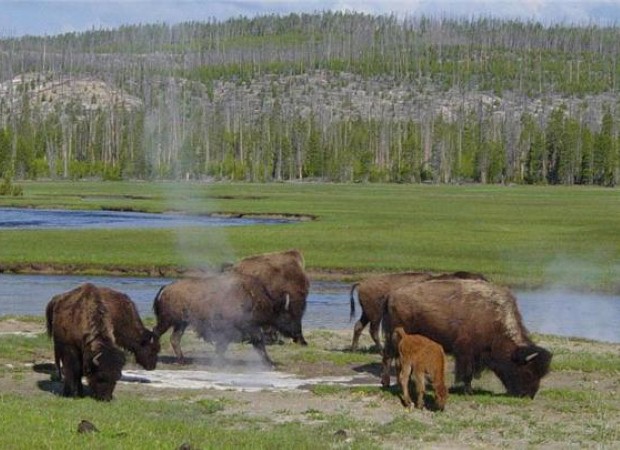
0,208,290,229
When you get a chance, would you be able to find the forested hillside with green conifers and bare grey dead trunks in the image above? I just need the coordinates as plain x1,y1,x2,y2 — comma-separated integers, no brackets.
0,12,620,186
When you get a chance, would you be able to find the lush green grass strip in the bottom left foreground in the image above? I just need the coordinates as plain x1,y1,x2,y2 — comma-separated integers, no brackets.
0,394,364,449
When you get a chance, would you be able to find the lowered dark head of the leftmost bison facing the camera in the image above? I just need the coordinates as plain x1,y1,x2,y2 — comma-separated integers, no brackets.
84,348,125,401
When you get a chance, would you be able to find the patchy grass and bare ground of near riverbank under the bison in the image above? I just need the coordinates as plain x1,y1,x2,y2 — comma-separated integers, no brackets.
0,319,620,449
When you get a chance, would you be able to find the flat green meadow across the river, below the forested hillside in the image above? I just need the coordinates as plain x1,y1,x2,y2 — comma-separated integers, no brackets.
0,182,620,291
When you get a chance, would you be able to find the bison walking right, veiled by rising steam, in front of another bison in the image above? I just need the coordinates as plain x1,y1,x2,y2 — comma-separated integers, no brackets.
153,272,298,366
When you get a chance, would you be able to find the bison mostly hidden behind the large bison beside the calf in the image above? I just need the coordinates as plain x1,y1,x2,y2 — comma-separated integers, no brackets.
350,272,485,351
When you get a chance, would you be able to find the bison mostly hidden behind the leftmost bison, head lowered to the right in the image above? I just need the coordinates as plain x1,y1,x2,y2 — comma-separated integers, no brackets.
46,285,160,379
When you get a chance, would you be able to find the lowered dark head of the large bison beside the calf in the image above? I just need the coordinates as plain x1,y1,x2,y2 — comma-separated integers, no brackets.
490,345,552,398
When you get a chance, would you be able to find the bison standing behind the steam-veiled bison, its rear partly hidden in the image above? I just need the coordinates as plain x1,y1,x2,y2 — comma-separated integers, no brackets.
230,249,310,345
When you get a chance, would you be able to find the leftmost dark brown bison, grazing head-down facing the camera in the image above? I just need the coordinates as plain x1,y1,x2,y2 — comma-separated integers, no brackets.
46,283,125,401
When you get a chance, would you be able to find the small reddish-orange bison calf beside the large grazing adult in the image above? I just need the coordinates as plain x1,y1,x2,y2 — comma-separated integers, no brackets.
393,327,448,411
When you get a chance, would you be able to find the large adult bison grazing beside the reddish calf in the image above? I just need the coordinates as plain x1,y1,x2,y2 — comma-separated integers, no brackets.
382,279,552,398
